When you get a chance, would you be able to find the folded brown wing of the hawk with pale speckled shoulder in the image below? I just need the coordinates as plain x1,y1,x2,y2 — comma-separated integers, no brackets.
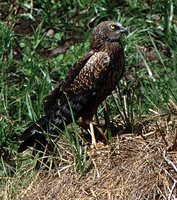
44,51,110,115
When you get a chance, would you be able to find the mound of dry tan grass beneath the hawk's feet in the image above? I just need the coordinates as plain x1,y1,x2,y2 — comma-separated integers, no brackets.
1,115,177,200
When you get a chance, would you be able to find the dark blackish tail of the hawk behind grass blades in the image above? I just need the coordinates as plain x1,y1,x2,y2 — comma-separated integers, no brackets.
18,106,72,152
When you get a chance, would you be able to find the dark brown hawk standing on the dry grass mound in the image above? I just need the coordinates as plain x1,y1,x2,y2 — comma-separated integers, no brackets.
19,21,127,152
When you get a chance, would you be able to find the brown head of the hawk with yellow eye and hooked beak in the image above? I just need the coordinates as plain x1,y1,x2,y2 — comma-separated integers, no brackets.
91,21,128,46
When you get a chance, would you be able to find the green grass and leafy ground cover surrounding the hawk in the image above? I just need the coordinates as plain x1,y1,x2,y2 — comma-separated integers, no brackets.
0,0,177,199
